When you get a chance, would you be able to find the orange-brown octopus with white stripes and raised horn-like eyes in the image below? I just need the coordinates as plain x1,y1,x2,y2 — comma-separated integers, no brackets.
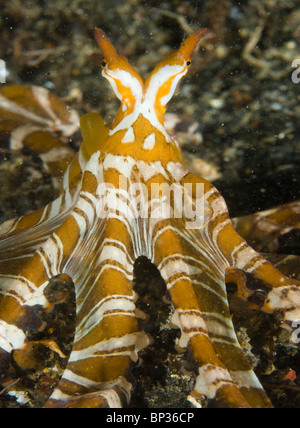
0,29,300,408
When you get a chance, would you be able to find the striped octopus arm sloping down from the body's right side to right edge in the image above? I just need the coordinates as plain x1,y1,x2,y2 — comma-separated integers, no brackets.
185,172,300,324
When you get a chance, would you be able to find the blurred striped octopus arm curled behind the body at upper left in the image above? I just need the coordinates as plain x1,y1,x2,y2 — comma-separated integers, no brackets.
0,85,79,190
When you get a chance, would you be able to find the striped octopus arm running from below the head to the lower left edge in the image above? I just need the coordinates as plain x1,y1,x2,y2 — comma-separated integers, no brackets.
0,112,104,386
